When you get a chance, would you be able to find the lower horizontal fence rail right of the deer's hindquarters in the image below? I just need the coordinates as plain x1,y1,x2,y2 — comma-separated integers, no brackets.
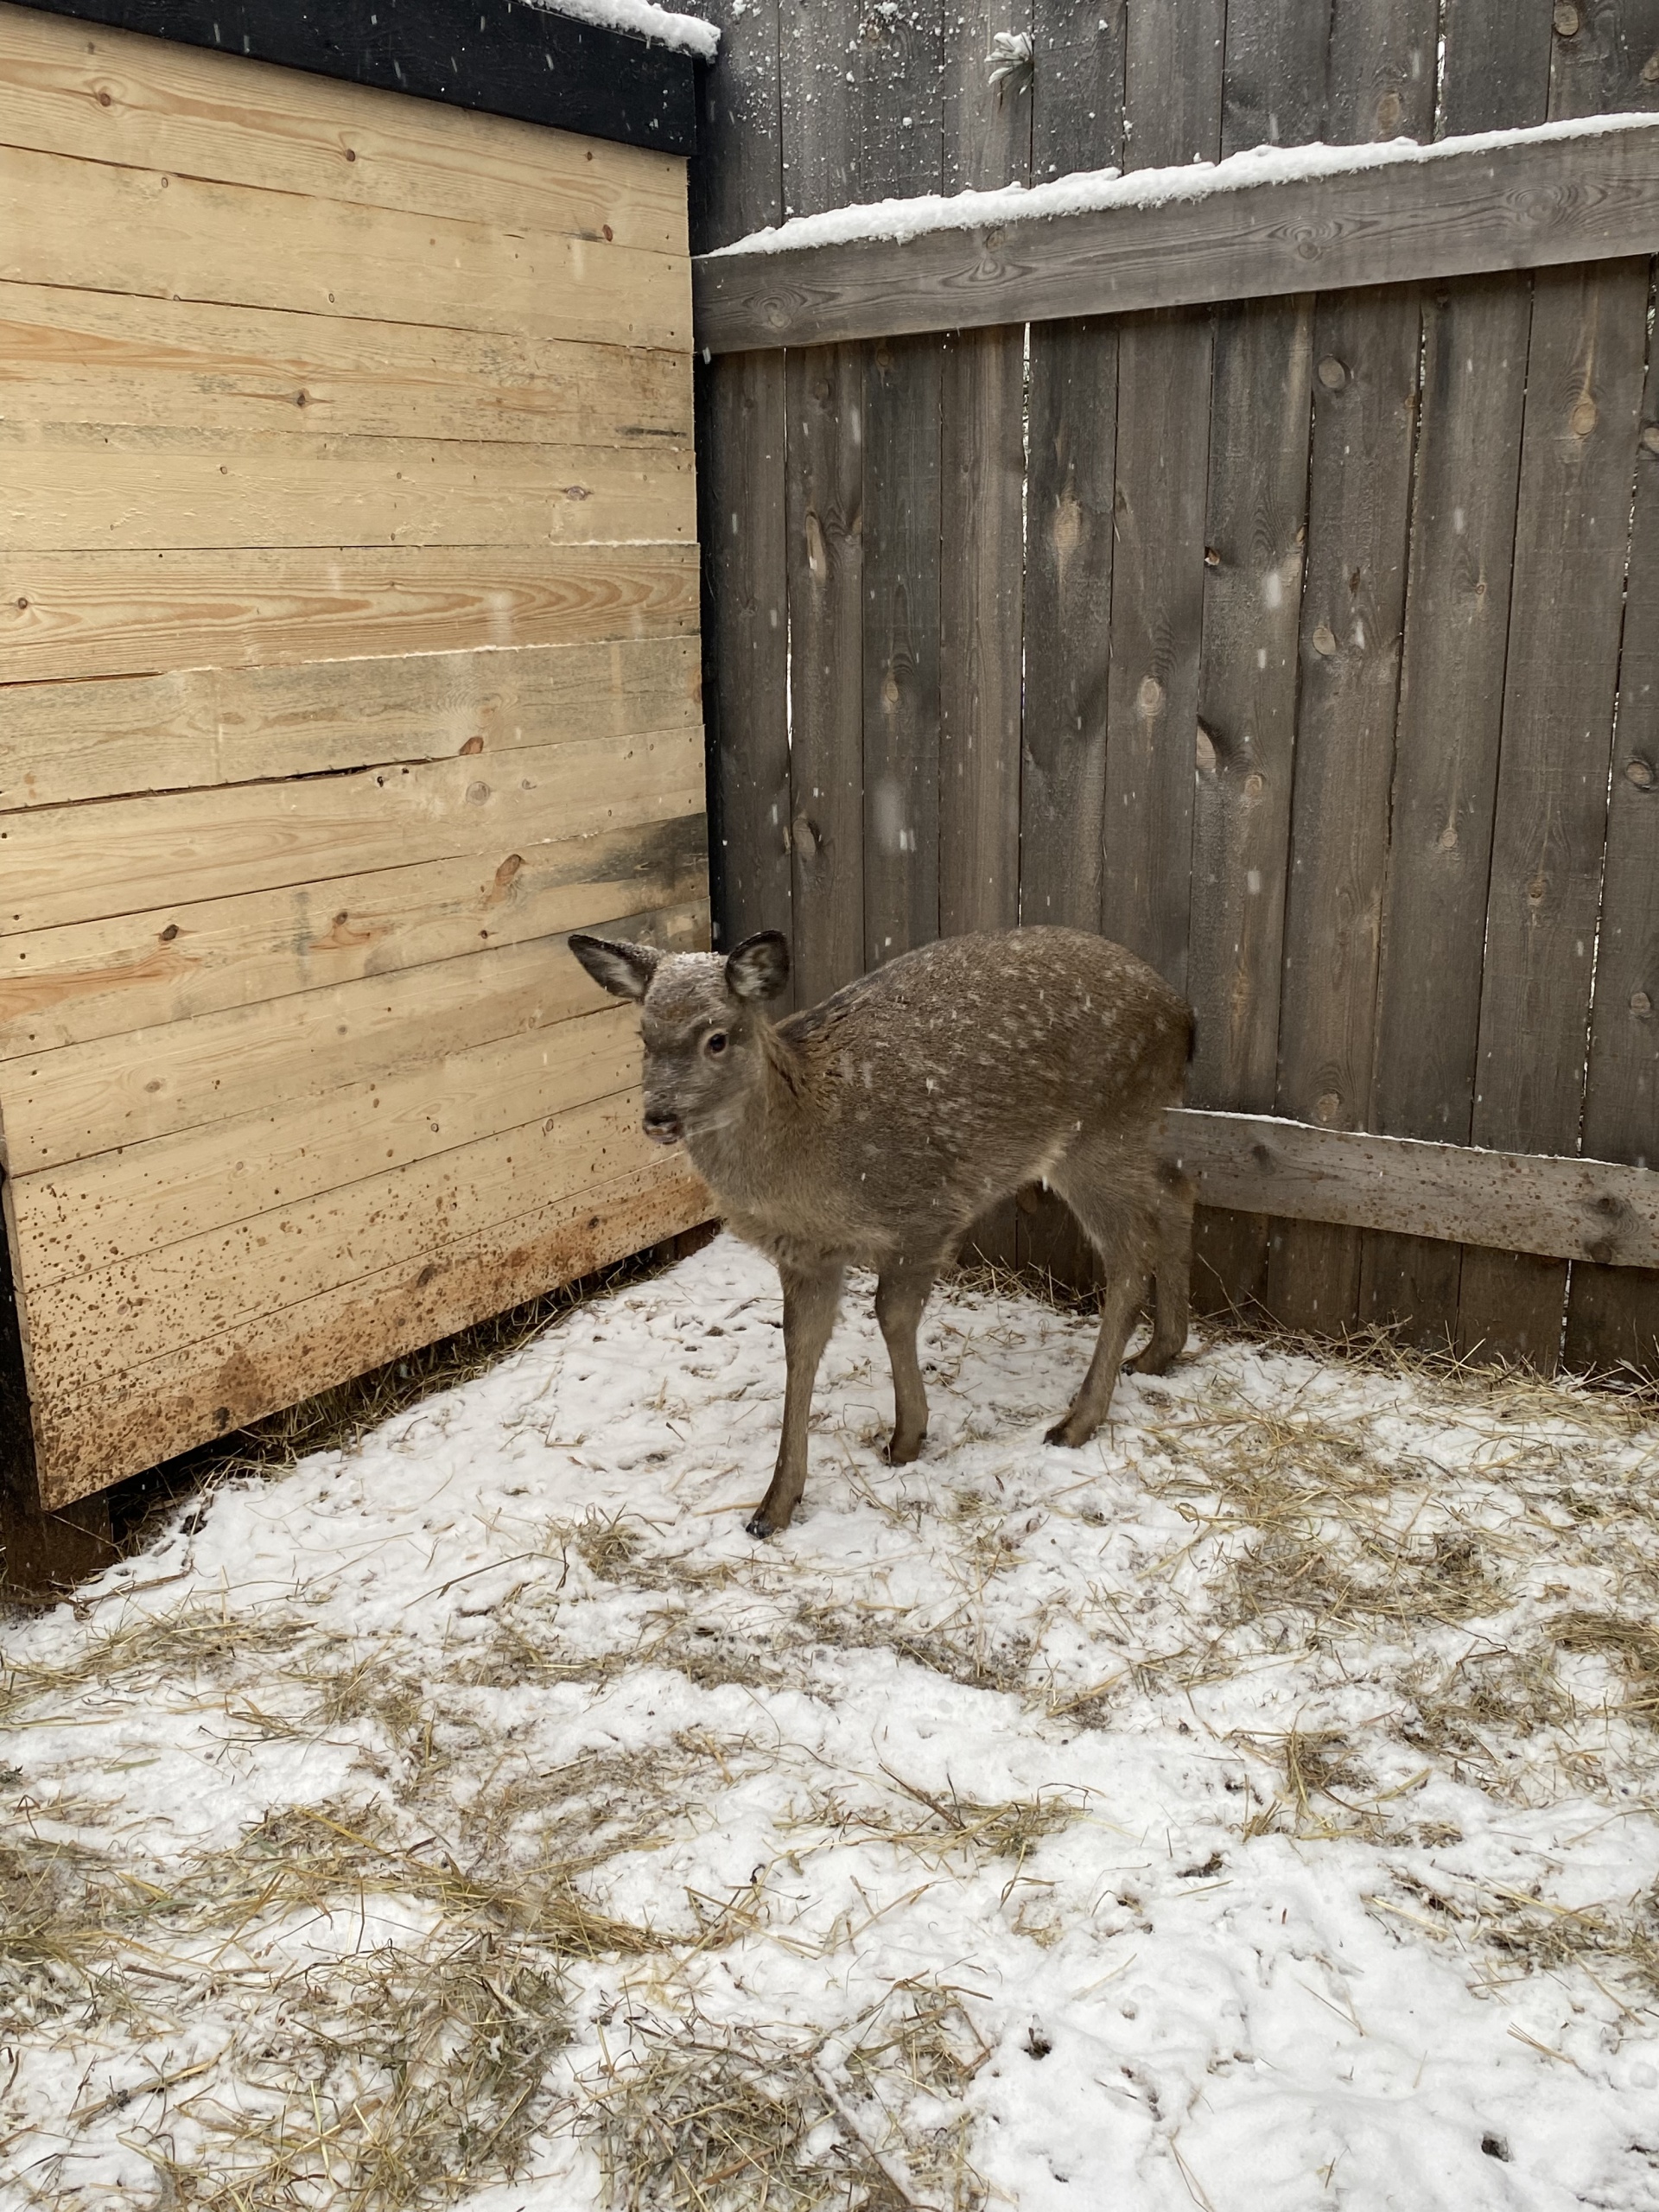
1170,1109,1659,1269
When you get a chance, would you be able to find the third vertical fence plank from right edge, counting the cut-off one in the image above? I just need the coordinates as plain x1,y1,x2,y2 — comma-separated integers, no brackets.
1360,0,1551,1344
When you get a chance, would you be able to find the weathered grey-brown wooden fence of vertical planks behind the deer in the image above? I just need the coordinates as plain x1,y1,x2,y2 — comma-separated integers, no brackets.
692,0,1659,1370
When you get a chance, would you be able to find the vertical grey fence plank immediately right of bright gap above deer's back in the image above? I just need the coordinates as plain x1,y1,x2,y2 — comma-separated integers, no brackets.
1018,0,1126,1283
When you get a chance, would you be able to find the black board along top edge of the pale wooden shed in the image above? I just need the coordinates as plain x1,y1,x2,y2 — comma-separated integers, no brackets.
0,0,696,153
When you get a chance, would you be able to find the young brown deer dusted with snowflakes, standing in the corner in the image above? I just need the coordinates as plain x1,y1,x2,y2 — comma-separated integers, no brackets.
569,927,1194,1537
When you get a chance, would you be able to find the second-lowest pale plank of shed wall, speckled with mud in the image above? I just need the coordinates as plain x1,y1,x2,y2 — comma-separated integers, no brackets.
20,1089,651,1398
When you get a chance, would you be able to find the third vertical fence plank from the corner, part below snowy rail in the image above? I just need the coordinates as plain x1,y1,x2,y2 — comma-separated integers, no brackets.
862,339,943,969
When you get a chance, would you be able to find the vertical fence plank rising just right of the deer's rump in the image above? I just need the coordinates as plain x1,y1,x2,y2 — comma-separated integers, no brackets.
1188,0,1332,1312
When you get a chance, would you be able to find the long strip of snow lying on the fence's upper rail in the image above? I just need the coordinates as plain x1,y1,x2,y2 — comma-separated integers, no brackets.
708,111,1655,261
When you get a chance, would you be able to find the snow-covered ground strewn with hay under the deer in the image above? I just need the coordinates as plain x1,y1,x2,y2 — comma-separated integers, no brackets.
0,1239,1659,2212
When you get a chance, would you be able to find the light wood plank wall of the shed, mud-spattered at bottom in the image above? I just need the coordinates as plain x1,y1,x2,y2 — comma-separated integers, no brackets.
0,4,708,1506
